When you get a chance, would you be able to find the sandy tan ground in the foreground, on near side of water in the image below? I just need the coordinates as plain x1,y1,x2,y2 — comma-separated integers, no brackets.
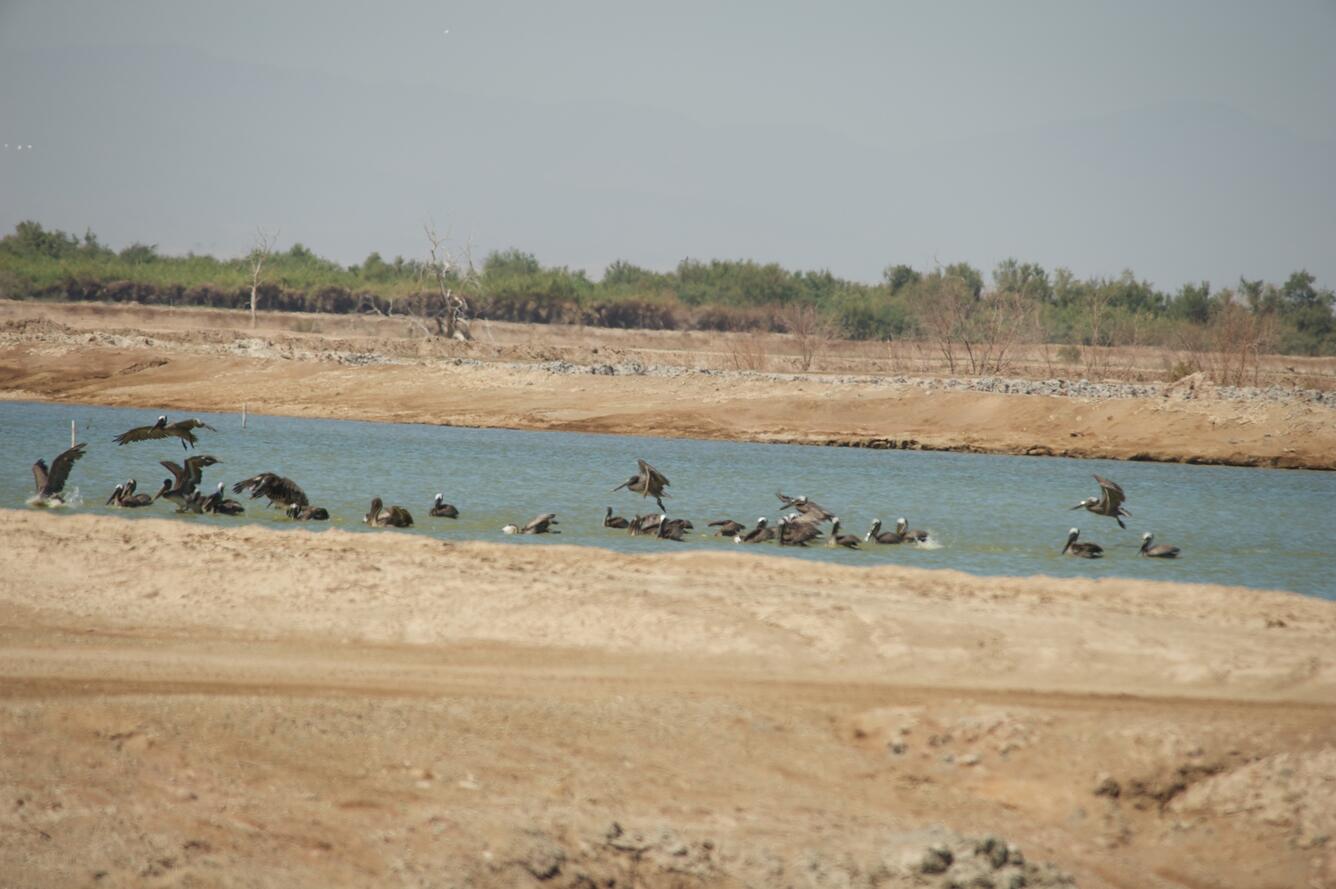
0,509,1336,888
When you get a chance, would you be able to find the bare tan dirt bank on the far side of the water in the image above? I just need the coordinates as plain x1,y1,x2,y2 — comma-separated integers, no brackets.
0,302,1336,469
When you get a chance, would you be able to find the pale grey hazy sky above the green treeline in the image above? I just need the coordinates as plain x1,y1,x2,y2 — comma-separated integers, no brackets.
0,0,1336,289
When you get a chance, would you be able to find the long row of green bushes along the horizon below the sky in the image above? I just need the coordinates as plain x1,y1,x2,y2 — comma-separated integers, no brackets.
0,222,1336,354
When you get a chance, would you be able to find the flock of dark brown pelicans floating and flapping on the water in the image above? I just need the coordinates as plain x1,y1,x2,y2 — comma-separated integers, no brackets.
29,417,1180,559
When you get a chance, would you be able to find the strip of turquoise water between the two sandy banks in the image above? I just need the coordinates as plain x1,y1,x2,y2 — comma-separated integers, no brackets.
0,402,1336,599
